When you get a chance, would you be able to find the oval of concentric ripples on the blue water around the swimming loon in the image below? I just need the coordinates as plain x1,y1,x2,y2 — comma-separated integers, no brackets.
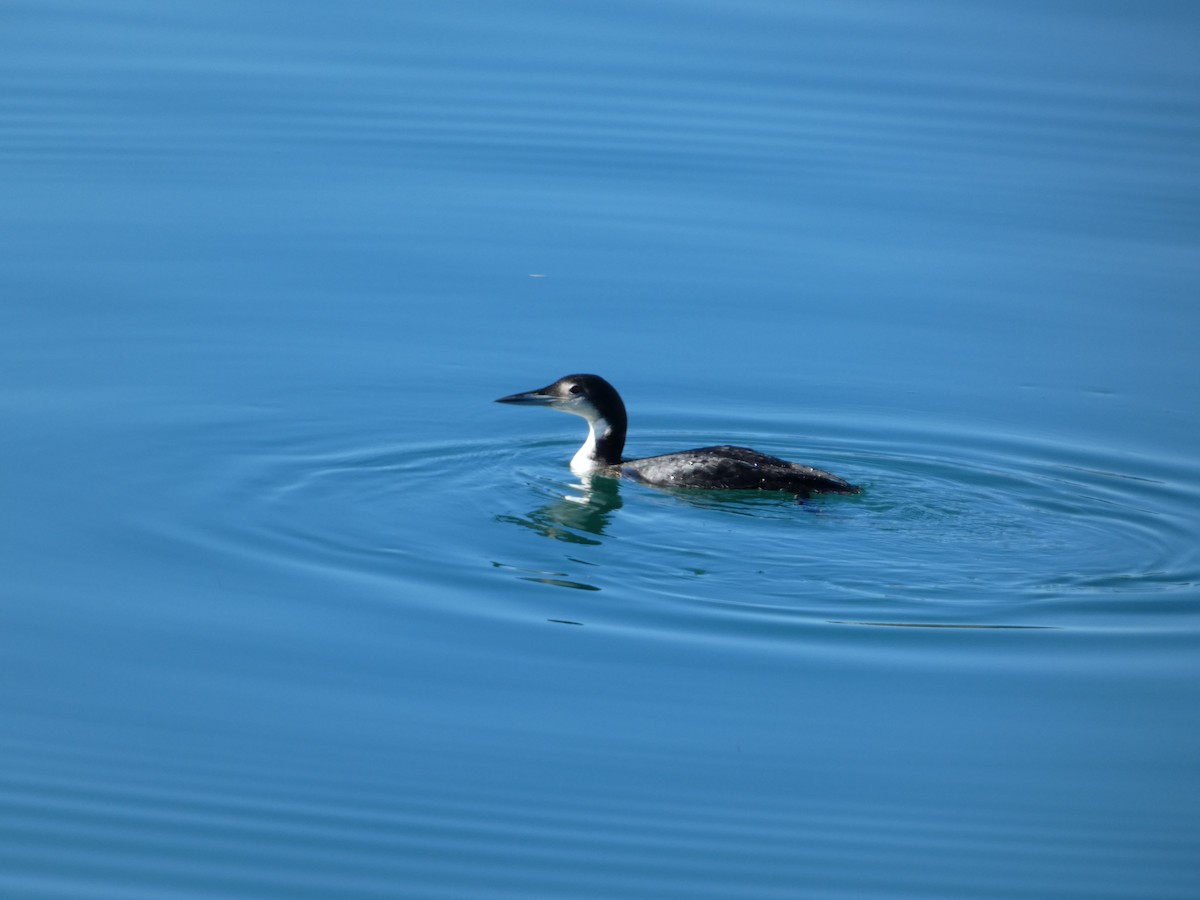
166,417,1200,632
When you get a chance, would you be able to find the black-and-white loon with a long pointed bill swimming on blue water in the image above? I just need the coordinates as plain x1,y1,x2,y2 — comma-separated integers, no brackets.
496,374,862,497
